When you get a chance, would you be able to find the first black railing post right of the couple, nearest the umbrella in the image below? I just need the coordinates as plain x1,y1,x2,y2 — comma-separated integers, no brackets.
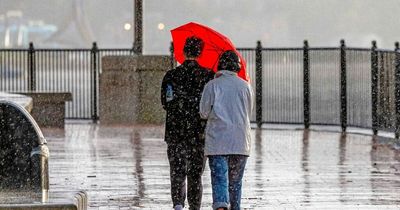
256,41,263,128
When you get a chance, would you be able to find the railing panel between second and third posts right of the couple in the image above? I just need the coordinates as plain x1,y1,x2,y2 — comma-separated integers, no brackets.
309,48,340,125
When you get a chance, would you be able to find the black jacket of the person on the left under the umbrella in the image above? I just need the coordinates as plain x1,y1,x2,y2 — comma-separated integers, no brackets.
161,60,214,143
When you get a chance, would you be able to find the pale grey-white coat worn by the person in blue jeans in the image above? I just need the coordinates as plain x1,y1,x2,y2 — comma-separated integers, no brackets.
200,70,254,156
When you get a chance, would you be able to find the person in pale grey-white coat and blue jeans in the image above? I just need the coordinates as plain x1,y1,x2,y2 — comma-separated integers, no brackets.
200,51,253,210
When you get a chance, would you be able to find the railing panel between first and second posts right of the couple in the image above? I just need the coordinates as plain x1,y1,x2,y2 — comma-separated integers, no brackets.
262,48,304,123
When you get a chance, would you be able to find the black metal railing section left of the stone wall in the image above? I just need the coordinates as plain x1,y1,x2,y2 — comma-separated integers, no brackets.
0,43,133,121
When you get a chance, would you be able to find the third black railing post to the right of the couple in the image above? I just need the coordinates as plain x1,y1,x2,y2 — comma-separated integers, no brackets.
340,39,347,132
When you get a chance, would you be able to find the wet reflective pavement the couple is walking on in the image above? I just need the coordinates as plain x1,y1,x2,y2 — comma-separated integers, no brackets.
43,123,400,210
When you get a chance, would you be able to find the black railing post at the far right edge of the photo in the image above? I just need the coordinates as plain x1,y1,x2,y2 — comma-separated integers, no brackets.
394,42,400,139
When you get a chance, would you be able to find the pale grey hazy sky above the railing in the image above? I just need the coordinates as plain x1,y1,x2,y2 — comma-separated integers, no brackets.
0,0,400,54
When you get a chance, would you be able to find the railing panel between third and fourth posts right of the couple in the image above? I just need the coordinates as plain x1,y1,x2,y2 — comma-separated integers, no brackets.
346,49,372,128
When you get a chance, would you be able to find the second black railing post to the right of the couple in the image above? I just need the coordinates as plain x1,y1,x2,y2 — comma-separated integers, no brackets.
303,40,310,129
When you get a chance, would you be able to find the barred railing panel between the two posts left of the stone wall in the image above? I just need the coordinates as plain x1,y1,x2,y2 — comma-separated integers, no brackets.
35,49,93,119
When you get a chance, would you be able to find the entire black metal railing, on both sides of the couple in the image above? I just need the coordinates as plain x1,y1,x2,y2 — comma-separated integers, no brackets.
0,40,400,137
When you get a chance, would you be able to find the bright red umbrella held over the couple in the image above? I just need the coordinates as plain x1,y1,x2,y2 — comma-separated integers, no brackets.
171,22,249,81
